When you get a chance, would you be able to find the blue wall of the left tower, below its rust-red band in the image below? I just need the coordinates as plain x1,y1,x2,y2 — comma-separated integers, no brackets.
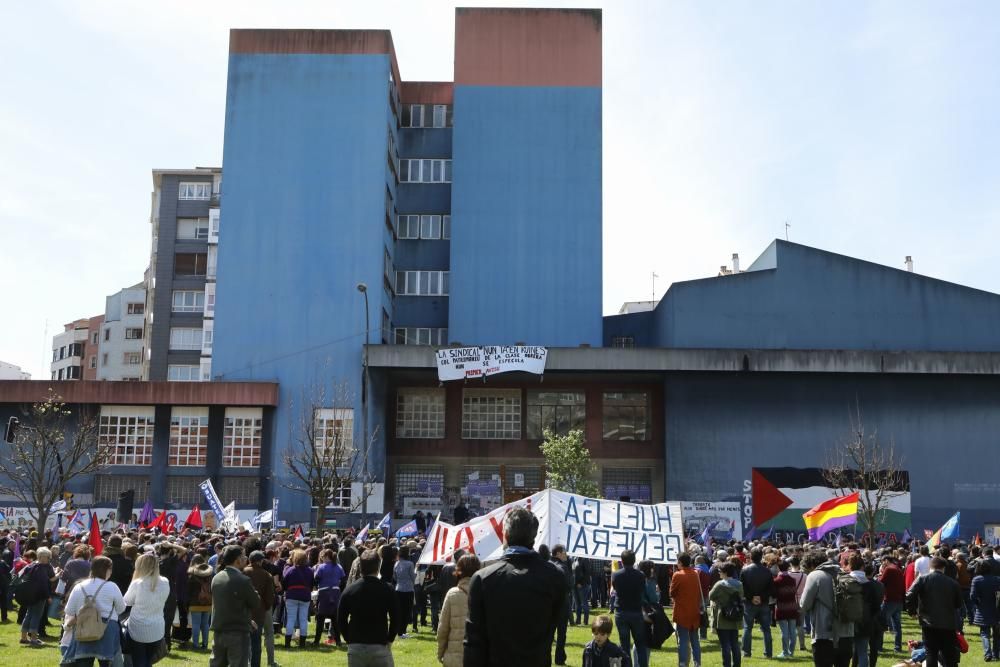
213,54,395,520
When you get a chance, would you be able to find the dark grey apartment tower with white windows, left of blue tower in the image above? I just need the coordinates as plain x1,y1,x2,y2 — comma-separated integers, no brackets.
142,167,222,381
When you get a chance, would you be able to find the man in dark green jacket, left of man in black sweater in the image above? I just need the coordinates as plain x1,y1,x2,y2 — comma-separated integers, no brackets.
209,544,261,667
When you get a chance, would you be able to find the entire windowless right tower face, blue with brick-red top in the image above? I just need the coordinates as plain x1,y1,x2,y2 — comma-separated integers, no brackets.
449,9,602,346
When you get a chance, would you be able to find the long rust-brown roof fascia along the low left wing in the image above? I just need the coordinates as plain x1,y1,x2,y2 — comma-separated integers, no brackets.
0,380,278,407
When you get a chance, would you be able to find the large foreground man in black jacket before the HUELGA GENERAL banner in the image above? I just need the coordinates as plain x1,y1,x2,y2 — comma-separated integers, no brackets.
464,507,568,667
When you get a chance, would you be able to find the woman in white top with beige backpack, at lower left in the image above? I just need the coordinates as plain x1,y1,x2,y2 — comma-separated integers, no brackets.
61,556,125,667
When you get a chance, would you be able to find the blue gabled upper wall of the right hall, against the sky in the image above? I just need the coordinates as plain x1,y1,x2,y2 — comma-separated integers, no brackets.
655,241,1000,352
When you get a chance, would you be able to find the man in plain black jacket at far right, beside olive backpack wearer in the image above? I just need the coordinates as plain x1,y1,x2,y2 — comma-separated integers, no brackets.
906,556,964,667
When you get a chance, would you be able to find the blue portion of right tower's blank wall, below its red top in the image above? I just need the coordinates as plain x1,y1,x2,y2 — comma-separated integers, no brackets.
449,85,602,347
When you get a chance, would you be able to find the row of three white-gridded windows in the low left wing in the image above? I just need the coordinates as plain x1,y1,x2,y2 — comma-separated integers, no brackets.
98,406,263,468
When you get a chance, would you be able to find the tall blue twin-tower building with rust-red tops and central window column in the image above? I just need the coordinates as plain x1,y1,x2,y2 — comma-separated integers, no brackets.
213,9,602,515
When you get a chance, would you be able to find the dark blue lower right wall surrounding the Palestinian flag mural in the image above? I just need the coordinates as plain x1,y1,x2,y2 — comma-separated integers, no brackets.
664,373,1000,537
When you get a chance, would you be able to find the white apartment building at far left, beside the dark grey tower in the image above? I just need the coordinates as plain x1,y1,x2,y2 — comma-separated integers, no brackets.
97,283,146,381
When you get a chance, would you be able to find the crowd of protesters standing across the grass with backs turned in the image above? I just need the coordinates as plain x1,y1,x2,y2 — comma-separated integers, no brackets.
0,508,1000,667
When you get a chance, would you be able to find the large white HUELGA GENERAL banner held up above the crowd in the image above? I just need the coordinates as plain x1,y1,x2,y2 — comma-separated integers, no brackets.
418,489,684,564
